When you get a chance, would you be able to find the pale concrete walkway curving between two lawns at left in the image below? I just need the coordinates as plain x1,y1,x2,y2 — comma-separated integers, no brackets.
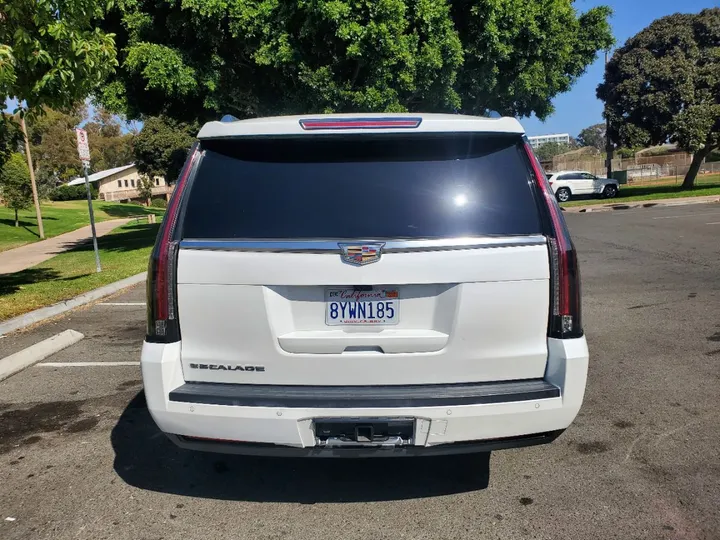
0,218,132,275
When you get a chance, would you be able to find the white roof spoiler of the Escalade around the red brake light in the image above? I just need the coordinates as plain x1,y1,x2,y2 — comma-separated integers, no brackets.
198,113,525,139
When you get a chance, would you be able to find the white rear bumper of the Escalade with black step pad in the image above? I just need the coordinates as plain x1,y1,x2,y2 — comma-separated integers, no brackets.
141,338,588,457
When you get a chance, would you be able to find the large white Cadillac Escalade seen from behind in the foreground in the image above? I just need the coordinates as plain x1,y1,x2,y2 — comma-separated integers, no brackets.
142,114,588,457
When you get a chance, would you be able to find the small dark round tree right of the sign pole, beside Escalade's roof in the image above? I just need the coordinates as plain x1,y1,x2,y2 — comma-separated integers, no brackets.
133,116,198,183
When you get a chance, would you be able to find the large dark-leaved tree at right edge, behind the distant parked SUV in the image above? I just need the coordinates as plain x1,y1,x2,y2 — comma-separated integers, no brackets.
597,8,720,189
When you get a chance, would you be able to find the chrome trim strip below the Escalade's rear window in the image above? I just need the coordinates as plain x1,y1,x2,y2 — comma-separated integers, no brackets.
180,235,547,254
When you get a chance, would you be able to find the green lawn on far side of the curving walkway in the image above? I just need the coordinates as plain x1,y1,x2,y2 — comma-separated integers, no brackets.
0,201,165,251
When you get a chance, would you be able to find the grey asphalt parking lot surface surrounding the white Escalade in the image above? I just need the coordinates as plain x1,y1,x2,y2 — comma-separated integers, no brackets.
0,205,720,540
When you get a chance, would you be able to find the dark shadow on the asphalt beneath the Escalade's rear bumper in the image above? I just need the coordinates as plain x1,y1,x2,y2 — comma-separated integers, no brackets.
111,392,490,504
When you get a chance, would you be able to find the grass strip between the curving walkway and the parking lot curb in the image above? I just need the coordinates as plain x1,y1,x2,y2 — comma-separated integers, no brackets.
0,223,160,321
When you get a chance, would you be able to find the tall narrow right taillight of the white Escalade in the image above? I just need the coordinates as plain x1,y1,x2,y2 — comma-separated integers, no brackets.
525,142,583,338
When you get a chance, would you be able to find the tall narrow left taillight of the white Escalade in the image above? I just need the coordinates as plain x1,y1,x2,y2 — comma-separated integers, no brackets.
146,145,198,343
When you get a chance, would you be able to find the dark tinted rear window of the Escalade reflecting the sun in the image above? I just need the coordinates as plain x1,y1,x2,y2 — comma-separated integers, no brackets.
182,134,541,239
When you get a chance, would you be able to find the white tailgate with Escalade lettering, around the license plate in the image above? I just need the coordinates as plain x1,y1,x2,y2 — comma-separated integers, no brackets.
178,237,549,385
